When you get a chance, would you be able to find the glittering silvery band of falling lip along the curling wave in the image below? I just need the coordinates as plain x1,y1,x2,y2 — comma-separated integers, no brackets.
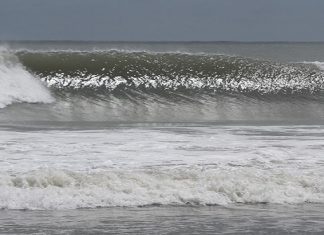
42,74,324,94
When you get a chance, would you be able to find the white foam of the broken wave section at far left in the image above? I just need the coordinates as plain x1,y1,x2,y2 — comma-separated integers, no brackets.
0,48,54,108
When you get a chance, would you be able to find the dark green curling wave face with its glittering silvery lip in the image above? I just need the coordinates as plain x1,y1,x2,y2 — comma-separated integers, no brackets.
17,51,324,95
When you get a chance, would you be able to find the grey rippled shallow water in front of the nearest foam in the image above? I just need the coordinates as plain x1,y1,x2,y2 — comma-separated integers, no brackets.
0,204,324,234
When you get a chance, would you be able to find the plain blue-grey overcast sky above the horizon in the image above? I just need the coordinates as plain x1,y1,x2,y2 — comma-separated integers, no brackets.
0,0,324,41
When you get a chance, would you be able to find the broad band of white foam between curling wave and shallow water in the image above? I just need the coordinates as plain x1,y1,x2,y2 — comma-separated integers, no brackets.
0,126,324,209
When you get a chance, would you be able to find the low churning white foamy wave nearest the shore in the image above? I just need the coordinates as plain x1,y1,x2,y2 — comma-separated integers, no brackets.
0,166,324,210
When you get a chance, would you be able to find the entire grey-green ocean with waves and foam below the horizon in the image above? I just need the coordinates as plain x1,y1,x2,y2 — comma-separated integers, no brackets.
0,42,324,234
